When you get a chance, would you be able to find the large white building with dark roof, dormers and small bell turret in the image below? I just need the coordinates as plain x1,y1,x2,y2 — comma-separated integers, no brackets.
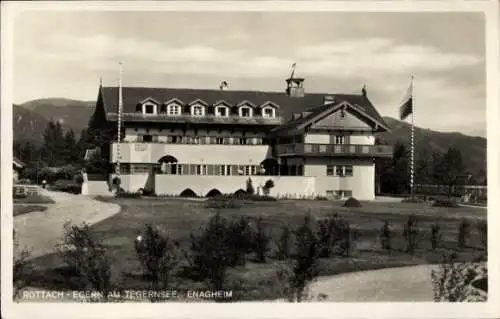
88,77,392,200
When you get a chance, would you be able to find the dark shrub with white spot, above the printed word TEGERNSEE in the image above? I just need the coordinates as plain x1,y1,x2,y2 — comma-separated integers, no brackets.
135,225,179,300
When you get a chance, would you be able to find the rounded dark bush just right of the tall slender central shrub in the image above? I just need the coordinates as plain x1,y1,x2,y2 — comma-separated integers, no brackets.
316,214,351,258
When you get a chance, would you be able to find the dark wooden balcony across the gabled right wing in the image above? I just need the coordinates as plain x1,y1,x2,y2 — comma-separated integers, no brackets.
275,143,392,157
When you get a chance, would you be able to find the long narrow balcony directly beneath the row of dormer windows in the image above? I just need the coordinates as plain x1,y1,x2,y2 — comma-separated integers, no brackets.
108,113,283,125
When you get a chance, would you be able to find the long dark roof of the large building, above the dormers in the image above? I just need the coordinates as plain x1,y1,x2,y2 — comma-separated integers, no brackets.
100,87,387,128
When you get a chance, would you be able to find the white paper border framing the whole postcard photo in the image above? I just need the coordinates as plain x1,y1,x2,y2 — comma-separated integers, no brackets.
1,0,500,319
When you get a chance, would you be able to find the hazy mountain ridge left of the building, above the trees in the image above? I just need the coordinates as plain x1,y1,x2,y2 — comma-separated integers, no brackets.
13,98,95,140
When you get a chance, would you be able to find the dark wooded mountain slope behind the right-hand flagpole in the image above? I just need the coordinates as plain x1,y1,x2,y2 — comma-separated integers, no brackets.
379,117,487,178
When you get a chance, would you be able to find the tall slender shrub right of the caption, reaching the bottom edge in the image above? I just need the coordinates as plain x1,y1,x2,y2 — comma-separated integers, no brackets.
278,215,319,302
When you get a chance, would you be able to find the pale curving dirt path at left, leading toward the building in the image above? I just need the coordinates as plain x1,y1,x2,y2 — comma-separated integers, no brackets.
14,190,120,258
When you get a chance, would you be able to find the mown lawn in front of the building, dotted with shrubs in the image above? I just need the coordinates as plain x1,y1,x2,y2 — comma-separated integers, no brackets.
21,198,486,300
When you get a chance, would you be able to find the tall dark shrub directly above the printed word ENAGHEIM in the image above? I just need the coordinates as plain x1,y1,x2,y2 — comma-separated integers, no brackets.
191,213,231,290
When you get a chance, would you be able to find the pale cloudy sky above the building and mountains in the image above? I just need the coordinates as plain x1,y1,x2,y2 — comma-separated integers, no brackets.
13,11,486,137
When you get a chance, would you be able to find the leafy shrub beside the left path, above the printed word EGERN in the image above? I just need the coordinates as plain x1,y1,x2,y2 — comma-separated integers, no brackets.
58,222,112,300
